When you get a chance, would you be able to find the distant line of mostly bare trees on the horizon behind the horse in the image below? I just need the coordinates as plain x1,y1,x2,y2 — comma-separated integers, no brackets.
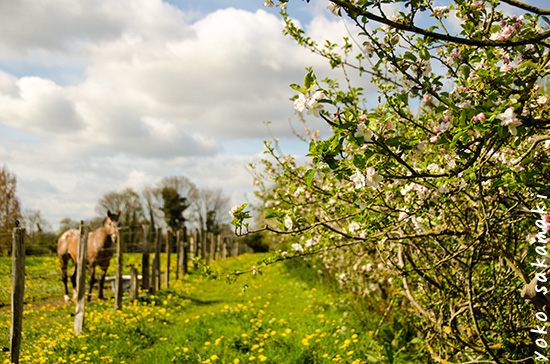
0,165,233,254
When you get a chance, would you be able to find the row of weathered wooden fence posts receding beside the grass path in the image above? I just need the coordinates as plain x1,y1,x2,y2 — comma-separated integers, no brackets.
10,223,252,363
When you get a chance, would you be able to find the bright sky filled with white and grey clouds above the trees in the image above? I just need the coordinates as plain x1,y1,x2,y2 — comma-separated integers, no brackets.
0,0,345,229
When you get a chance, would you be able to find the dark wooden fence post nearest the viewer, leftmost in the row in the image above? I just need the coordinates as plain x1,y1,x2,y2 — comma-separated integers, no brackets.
10,221,25,363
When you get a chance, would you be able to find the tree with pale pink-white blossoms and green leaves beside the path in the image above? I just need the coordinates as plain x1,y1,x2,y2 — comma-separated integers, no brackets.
233,0,550,363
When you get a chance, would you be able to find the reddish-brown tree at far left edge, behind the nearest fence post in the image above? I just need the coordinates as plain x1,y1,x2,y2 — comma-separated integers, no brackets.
0,165,22,254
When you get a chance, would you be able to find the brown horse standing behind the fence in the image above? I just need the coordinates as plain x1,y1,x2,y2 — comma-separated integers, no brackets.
57,211,120,302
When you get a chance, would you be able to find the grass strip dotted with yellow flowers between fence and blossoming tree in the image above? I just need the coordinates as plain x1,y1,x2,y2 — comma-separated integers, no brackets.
0,254,429,364
